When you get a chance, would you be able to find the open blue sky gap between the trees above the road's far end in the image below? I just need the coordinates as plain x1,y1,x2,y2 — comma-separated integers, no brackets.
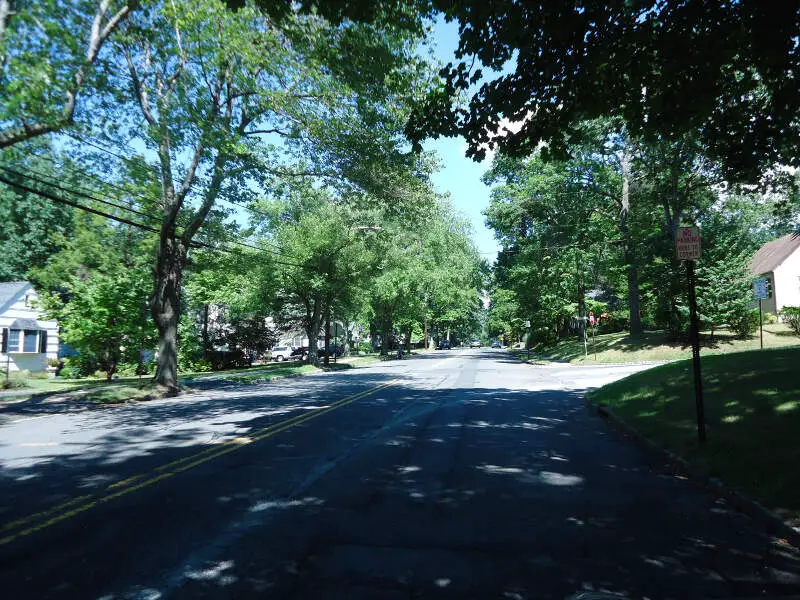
423,18,500,262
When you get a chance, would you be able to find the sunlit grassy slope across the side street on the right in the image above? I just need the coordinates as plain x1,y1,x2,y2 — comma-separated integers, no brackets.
531,323,800,363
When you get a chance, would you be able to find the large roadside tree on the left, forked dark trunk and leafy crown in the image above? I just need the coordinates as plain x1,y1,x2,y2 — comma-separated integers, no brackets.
102,0,432,392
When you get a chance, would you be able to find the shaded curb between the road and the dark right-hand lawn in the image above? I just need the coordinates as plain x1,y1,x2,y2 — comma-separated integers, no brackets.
584,397,800,549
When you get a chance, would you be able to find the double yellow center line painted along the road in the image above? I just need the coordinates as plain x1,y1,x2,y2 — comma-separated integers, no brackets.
0,379,399,546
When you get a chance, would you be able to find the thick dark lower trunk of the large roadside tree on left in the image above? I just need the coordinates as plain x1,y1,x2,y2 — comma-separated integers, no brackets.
150,235,186,395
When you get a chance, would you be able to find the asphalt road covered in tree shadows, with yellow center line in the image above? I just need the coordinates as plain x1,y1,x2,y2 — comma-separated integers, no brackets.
0,349,800,600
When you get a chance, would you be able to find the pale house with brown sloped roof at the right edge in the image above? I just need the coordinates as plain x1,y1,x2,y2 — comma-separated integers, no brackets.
750,232,800,314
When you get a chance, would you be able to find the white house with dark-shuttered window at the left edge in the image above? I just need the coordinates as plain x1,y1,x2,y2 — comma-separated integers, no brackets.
0,281,58,372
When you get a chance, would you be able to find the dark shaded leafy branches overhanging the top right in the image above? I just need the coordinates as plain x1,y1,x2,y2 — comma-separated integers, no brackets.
407,0,800,181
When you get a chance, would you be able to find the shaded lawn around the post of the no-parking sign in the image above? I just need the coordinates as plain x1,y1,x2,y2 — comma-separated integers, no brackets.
590,348,800,518
